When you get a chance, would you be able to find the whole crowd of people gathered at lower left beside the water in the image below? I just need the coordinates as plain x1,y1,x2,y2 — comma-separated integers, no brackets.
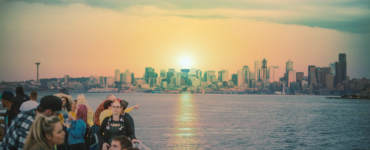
0,86,141,150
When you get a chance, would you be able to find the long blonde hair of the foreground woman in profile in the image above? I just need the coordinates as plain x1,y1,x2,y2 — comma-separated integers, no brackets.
23,114,60,150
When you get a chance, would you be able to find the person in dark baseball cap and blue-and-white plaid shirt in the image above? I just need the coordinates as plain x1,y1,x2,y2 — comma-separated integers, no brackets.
0,95,68,150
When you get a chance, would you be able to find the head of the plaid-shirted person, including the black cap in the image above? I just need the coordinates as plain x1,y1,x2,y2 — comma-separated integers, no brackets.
36,95,68,116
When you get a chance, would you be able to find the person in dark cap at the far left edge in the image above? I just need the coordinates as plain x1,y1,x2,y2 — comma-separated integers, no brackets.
1,91,20,132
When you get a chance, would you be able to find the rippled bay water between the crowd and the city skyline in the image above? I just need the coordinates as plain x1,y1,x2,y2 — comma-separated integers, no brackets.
35,93,370,150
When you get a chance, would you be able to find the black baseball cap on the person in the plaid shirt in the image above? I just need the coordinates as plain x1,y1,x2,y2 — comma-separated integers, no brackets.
39,95,68,114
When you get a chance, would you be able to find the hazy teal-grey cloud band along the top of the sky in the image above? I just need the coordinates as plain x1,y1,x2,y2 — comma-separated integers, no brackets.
4,0,370,33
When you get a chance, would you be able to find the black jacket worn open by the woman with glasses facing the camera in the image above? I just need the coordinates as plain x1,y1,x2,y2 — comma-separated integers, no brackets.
97,115,136,145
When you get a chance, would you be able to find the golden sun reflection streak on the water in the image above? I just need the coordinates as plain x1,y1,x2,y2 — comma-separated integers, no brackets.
172,94,198,149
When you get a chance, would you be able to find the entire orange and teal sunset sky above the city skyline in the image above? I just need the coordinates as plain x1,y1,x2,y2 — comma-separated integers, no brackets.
0,0,370,81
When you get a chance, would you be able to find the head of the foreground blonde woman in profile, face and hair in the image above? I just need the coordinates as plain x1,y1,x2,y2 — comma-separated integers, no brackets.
23,115,65,150
